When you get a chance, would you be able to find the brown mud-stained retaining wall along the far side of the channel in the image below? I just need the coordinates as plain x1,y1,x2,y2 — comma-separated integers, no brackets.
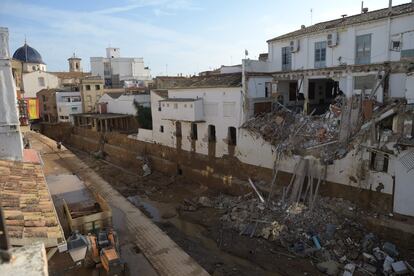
43,124,392,212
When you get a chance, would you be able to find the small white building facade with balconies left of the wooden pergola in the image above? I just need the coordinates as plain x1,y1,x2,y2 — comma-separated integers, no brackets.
56,91,83,122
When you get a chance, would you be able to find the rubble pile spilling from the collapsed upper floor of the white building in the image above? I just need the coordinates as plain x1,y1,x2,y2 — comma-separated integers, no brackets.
242,109,339,153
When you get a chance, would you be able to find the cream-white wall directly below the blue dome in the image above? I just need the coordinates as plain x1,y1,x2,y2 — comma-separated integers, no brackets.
22,71,59,98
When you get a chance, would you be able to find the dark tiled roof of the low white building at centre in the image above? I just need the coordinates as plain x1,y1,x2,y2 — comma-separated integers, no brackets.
156,73,242,89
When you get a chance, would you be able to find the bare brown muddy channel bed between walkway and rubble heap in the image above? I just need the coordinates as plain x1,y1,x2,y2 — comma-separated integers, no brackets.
67,148,334,275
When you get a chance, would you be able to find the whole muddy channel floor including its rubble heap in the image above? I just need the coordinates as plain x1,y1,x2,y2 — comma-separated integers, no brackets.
68,148,414,275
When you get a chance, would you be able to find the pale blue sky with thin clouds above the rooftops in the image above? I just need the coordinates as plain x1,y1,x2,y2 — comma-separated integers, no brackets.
0,0,411,76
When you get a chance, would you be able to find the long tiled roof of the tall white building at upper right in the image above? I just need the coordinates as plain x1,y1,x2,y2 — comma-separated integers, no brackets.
267,3,414,42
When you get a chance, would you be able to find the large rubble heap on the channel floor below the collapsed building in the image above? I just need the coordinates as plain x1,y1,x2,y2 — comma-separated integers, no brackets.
204,194,414,275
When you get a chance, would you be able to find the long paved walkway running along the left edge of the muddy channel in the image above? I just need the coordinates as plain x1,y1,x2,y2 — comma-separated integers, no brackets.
28,132,208,276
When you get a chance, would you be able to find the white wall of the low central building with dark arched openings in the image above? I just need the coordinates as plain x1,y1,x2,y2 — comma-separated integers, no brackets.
147,87,242,157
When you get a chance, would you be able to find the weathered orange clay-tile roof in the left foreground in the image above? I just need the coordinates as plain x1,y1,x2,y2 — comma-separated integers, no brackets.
0,160,65,247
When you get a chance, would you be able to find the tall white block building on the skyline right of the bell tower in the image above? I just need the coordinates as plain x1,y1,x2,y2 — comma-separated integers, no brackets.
90,48,151,87
